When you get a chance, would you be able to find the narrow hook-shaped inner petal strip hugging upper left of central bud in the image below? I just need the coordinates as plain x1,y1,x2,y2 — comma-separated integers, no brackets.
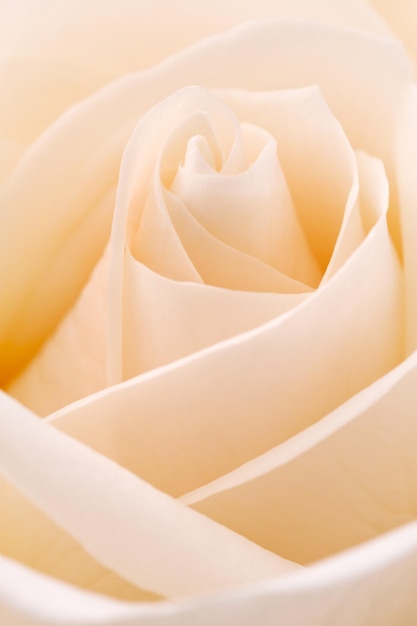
127,92,242,282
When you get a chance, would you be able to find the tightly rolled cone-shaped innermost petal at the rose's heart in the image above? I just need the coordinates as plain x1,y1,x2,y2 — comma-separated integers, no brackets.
170,124,320,285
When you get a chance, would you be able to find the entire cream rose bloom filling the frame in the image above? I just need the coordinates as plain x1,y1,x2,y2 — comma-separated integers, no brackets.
0,3,417,624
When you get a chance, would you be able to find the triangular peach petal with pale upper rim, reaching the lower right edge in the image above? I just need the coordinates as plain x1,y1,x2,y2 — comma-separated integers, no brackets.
182,346,417,563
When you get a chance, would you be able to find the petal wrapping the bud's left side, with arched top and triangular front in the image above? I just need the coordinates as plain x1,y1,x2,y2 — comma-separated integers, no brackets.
118,88,322,377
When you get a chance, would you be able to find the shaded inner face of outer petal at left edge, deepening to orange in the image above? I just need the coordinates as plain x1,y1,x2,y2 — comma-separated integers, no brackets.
0,116,123,381
